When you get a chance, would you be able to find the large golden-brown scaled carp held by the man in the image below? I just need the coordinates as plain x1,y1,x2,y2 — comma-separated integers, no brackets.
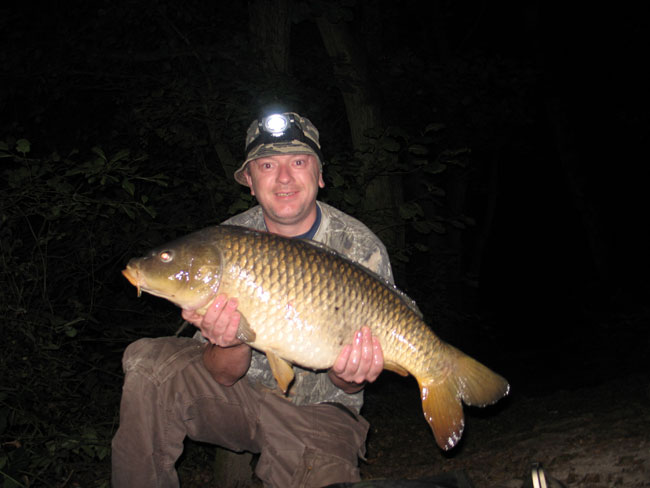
123,225,509,450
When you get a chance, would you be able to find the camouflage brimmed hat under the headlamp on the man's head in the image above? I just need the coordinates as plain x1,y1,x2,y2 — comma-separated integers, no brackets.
235,112,323,186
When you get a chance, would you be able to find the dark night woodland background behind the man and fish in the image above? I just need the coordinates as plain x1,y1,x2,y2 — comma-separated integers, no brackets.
0,0,650,486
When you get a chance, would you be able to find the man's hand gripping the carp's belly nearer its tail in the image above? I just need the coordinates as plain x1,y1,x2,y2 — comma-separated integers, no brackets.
329,327,384,393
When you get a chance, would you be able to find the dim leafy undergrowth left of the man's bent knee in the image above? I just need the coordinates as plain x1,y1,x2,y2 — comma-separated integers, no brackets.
0,139,168,486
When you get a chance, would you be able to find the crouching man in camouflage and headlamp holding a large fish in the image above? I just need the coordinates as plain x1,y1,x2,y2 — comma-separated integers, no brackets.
112,113,393,488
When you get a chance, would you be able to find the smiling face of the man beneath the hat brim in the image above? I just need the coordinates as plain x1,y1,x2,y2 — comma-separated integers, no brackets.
245,154,325,235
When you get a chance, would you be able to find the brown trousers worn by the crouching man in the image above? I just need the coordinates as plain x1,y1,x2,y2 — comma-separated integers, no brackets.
112,337,368,488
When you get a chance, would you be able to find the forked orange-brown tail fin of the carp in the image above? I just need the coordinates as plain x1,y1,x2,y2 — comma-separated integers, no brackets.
417,344,510,451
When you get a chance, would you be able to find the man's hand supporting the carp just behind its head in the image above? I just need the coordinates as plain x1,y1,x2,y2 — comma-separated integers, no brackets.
182,294,242,347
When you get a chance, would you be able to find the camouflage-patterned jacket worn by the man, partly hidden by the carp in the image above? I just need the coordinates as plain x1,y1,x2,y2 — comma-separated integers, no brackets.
201,202,393,413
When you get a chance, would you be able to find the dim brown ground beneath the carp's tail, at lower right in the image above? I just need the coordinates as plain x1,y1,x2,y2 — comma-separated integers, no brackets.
362,377,650,488
